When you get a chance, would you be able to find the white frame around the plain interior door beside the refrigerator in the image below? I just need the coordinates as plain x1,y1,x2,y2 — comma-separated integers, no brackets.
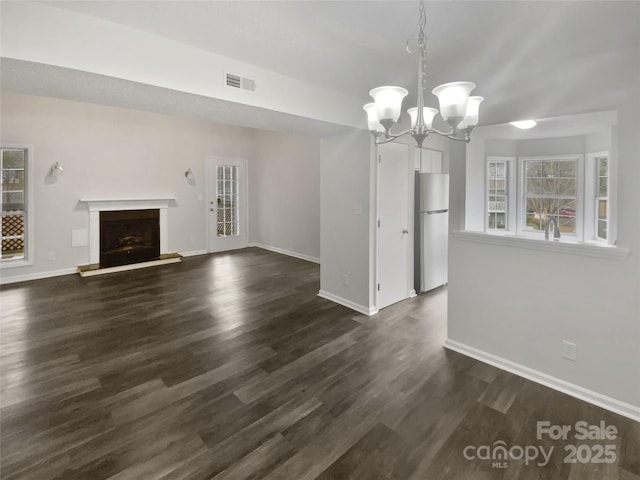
373,141,416,312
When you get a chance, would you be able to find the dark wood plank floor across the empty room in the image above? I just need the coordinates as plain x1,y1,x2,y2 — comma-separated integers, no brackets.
0,249,640,480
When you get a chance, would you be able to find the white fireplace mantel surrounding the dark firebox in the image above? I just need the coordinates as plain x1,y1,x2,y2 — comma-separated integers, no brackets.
80,197,175,264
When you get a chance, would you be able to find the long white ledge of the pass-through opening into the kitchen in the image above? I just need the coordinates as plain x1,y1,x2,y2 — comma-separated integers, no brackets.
452,230,631,260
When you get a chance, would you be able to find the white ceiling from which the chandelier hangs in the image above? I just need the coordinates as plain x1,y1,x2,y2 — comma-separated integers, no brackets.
3,0,640,134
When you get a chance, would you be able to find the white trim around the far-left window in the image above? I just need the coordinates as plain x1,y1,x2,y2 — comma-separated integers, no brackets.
0,143,35,269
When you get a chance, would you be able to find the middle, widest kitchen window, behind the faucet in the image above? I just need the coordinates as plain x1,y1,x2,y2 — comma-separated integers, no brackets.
522,157,581,236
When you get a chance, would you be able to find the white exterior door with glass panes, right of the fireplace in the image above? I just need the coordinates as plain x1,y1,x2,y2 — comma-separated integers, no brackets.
206,157,249,252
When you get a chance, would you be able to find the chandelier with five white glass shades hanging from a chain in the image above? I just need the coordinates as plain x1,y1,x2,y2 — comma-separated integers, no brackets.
363,0,484,147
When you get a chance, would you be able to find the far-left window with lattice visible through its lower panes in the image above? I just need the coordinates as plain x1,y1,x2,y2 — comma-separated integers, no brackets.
0,146,32,266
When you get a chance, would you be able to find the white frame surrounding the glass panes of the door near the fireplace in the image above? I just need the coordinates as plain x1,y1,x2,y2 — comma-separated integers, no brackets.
204,155,249,253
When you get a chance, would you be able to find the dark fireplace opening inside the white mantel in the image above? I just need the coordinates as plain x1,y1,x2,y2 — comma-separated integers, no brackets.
100,209,160,268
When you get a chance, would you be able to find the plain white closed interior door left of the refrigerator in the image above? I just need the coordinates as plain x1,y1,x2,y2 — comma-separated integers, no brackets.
378,143,413,309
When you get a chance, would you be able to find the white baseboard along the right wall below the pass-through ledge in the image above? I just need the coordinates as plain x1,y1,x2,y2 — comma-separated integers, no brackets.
444,339,640,422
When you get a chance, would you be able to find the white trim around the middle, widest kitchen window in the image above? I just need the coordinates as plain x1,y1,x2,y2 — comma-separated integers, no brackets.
517,153,585,242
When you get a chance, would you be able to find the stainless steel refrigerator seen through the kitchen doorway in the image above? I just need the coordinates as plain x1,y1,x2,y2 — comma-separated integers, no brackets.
413,173,449,293
